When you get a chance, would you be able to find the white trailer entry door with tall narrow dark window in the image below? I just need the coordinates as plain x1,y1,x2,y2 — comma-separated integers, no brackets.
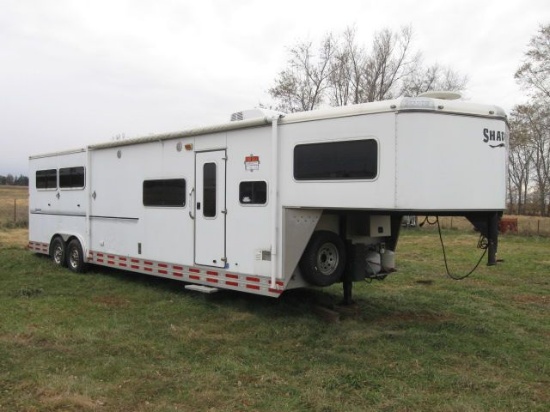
195,150,227,268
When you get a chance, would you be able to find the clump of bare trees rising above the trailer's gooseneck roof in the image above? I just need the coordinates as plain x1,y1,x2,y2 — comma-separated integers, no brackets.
269,27,467,112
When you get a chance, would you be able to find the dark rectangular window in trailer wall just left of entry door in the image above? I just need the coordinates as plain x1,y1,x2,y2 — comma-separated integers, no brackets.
143,179,186,207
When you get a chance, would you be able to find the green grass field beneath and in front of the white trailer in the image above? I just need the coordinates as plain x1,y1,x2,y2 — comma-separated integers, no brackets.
0,229,550,412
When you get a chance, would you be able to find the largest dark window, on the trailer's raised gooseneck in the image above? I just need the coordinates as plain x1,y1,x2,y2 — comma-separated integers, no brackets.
294,139,378,180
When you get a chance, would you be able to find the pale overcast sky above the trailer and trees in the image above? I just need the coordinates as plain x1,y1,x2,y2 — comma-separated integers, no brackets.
0,0,550,175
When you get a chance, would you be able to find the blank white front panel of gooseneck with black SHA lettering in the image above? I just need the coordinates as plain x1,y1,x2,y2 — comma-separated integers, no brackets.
395,112,507,211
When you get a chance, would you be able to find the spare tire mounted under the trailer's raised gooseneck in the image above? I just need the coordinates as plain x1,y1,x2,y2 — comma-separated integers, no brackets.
299,230,346,286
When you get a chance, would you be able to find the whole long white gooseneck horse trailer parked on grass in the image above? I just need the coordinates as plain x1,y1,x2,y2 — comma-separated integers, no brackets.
29,97,508,301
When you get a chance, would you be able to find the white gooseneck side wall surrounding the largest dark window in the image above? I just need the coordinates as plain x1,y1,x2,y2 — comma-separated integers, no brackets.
280,112,395,210
